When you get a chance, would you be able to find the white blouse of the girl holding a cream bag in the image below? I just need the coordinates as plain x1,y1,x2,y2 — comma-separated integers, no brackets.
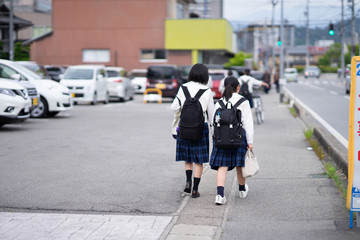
213,93,254,144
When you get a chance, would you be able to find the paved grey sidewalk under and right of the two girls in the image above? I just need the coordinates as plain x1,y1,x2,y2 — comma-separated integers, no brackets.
163,90,360,240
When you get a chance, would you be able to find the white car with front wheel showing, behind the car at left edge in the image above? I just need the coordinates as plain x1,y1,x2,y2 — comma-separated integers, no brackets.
0,60,72,118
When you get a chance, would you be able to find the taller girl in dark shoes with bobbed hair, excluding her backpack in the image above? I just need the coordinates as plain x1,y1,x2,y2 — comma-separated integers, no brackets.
171,63,214,198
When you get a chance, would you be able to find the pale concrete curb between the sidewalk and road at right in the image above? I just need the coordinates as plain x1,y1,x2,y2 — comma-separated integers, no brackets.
283,87,348,177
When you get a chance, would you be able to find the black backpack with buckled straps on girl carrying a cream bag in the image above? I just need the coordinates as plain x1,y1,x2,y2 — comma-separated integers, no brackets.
214,98,246,148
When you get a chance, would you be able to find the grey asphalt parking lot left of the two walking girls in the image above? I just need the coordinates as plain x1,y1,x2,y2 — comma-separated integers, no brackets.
0,96,185,214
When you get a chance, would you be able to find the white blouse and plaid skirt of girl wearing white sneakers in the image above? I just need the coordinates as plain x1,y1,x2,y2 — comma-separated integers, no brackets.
210,93,254,171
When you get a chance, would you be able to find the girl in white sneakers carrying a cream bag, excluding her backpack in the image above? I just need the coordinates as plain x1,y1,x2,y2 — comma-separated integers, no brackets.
210,77,254,205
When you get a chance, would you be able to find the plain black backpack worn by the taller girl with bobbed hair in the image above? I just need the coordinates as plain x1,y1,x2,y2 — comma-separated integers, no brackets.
179,86,207,140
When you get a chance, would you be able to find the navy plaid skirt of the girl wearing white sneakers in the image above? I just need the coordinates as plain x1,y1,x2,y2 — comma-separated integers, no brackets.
210,131,247,171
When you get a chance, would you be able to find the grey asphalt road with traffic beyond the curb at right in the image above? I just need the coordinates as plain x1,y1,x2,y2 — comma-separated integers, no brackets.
286,74,350,139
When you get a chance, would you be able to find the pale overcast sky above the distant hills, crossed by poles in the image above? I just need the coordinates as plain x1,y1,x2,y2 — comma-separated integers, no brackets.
224,0,360,27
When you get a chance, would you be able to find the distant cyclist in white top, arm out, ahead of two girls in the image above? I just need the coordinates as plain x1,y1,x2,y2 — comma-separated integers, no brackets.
238,69,269,108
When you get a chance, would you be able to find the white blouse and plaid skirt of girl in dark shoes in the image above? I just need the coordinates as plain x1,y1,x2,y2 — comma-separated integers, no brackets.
171,81,214,163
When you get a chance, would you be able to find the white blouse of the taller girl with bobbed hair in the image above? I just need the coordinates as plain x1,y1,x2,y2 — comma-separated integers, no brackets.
171,81,214,135
